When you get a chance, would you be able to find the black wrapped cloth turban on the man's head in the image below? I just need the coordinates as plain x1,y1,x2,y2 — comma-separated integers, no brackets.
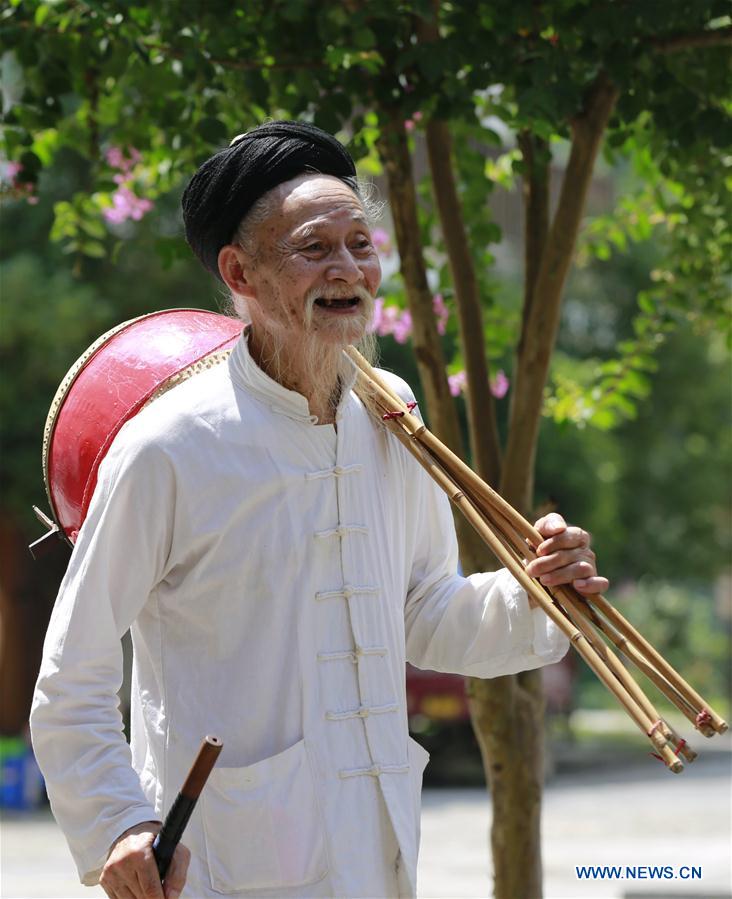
182,121,356,278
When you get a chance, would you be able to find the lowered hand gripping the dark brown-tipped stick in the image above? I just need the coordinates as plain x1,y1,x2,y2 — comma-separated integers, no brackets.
99,821,191,899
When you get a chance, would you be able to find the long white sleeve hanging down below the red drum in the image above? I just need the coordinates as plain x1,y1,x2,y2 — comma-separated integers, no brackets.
31,430,174,884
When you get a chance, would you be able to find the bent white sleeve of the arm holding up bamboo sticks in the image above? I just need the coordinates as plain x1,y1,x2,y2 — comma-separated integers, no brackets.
404,442,569,678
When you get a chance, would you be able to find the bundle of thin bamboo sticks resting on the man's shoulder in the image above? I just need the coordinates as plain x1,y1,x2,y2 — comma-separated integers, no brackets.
346,347,727,773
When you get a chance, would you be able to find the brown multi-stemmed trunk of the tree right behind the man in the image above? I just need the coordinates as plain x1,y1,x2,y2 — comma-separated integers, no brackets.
379,63,616,899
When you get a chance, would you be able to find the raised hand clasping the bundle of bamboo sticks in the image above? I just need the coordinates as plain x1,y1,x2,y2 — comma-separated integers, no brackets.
526,512,608,594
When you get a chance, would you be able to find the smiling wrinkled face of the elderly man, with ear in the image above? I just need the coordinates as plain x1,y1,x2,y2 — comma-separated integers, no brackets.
219,175,381,347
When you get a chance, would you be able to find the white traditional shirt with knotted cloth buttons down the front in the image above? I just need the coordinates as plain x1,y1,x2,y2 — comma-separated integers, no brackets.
31,336,567,897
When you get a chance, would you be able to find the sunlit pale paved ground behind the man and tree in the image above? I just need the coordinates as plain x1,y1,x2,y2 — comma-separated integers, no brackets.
0,738,732,899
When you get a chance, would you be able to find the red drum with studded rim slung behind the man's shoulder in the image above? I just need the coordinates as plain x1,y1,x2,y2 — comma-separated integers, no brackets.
43,309,242,543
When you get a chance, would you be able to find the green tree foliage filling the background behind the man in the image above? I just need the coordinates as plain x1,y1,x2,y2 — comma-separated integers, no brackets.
0,0,732,712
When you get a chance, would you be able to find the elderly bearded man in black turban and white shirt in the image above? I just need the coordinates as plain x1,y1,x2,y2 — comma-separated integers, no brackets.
32,122,607,899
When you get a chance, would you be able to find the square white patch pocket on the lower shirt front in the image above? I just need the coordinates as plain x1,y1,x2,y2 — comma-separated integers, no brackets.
201,740,328,893
